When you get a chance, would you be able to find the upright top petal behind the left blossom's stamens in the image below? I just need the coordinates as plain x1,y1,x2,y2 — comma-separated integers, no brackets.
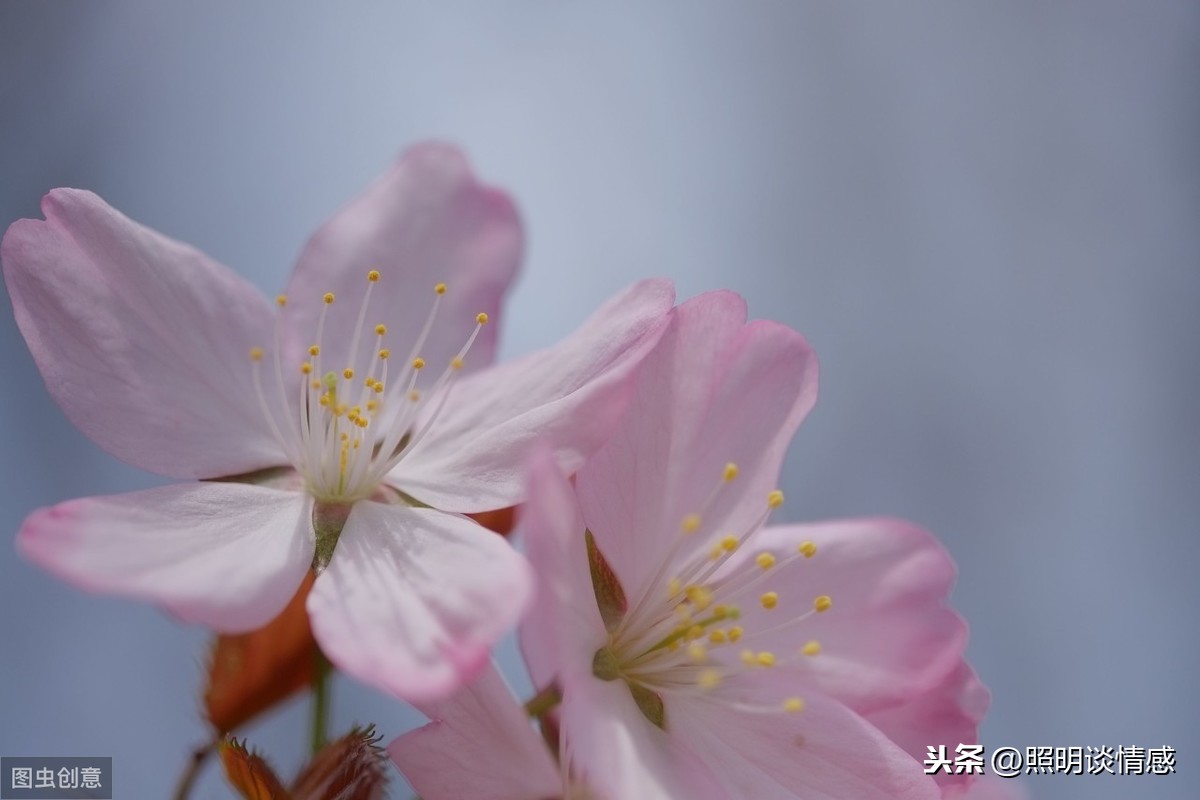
284,144,522,374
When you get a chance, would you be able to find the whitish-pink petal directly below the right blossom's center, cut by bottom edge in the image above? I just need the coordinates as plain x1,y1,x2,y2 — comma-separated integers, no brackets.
562,675,715,800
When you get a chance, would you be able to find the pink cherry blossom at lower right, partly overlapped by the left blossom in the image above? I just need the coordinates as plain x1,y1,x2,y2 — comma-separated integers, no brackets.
506,293,986,800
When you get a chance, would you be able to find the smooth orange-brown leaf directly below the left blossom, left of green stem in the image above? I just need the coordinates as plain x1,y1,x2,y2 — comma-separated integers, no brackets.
204,572,317,734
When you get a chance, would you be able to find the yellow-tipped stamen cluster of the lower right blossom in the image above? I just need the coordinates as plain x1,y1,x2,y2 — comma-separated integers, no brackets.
593,463,833,726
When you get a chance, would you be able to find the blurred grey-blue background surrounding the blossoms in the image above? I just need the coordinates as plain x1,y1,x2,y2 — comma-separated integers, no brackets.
0,0,1200,800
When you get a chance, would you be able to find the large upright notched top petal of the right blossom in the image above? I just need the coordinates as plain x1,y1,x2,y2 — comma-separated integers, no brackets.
577,291,816,600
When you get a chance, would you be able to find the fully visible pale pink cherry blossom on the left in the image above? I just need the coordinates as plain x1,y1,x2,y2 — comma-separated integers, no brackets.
0,145,673,698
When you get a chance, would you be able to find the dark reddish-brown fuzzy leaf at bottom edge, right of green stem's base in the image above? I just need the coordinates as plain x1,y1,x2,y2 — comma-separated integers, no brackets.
292,726,388,800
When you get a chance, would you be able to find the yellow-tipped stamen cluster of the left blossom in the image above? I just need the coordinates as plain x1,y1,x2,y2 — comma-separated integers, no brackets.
250,270,487,504
